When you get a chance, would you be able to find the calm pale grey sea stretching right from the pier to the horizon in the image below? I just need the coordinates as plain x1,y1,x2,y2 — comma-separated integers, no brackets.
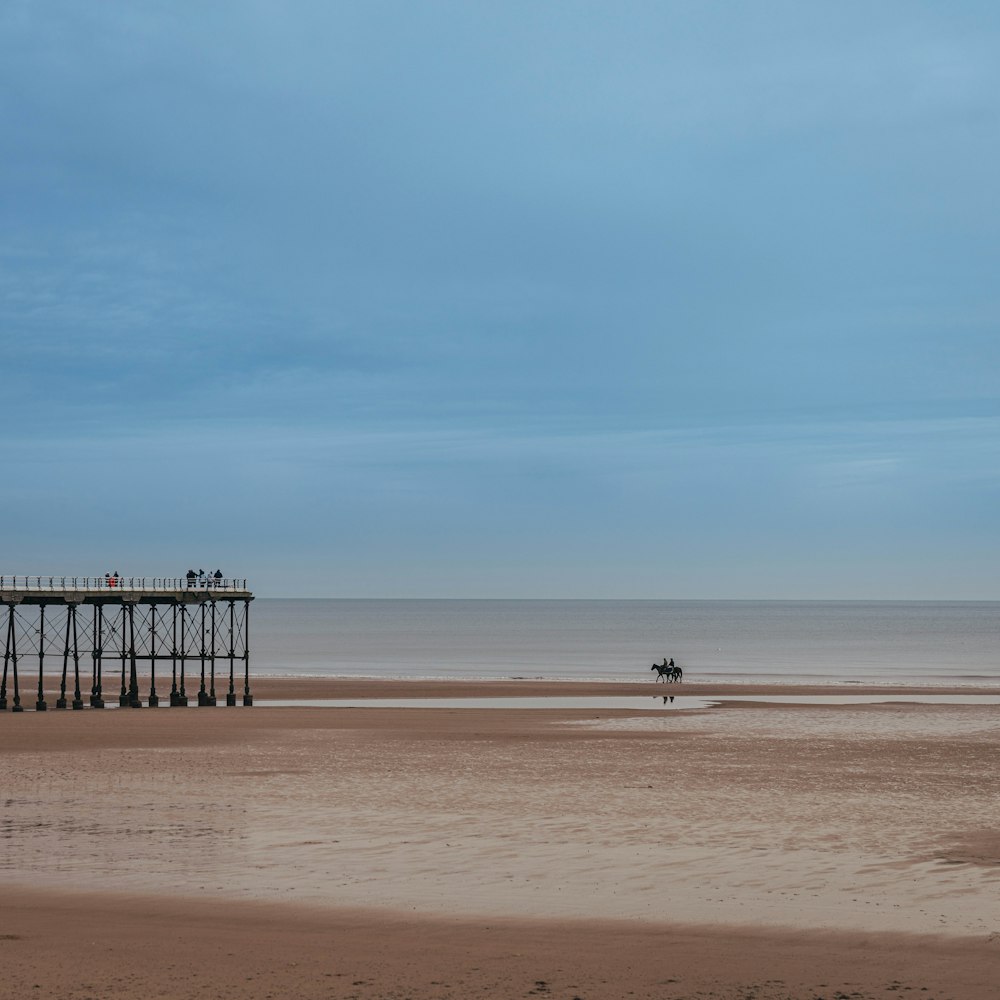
250,598,1000,686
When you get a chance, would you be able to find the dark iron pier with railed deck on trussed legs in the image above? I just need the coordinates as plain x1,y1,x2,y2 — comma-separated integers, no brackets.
0,576,253,712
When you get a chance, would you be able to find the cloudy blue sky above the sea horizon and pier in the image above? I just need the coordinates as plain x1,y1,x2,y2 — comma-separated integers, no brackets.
0,0,1000,600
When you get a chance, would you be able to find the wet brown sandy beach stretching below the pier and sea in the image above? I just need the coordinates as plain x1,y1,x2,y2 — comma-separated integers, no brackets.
0,678,1000,1000
